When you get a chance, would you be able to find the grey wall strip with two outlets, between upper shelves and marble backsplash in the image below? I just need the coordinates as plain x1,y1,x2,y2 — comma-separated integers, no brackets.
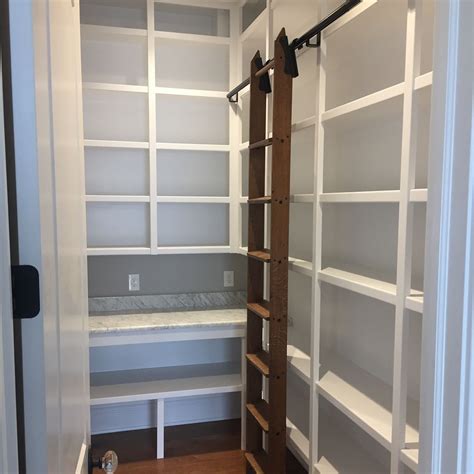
88,254,247,297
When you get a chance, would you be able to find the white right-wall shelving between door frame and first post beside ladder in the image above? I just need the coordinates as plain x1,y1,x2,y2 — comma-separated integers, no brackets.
310,0,433,473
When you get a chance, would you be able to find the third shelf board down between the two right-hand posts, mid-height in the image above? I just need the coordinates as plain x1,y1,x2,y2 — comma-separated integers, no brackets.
318,267,397,304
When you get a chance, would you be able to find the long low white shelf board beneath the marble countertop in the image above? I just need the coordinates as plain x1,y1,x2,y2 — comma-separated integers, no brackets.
91,363,242,406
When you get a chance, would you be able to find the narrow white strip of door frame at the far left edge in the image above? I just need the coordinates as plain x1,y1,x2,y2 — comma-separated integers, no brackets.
0,42,18,473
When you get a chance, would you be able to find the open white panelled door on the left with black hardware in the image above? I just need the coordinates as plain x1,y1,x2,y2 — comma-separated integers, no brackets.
10,0,90,474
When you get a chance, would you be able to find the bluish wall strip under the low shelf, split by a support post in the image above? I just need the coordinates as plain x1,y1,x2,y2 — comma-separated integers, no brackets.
91,392,241,434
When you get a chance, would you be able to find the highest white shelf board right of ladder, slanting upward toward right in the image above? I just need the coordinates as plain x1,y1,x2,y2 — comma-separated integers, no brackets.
321,83,405,125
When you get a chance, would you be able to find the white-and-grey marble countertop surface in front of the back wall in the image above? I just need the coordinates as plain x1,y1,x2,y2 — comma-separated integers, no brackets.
89,309,247,335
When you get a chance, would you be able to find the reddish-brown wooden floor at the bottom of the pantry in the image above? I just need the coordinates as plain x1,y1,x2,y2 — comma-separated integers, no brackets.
92,420,306,474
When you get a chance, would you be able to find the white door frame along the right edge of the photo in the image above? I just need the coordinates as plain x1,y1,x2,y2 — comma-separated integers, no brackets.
419,0,474,474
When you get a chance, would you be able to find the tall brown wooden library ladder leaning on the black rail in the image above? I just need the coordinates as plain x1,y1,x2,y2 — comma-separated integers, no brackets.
245,29,297,474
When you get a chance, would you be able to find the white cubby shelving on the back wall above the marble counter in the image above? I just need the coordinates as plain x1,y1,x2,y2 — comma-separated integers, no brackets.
81,0,239,255
